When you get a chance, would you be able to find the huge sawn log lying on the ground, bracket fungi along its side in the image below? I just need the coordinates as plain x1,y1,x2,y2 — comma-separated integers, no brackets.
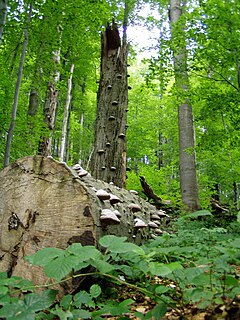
0,156,168,290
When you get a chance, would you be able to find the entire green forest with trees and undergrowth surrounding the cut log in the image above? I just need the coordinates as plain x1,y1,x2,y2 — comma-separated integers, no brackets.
0,0,240,320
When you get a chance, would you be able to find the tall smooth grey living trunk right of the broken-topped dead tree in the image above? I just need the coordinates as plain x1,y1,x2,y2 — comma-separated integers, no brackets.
170,0,200,212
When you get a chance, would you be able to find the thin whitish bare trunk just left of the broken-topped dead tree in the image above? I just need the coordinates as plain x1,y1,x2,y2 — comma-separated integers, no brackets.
60,64,74,161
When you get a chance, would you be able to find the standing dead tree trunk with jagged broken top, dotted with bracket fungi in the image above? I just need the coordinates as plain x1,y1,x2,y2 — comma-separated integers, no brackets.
91,21,128,188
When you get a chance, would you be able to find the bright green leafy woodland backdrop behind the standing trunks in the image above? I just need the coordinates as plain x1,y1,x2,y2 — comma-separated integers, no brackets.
0,0,240,209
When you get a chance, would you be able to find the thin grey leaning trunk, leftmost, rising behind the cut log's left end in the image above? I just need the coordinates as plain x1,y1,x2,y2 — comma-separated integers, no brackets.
4,3,32,167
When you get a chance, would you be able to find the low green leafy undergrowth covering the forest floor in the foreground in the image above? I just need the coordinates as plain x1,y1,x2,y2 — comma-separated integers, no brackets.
0,211,240,320
